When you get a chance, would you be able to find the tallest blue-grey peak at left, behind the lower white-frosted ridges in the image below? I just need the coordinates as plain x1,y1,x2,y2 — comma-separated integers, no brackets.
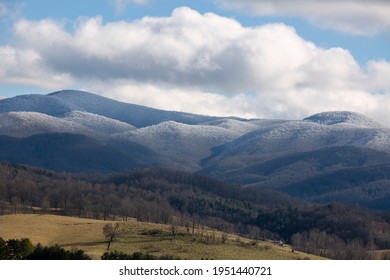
0,90,224,127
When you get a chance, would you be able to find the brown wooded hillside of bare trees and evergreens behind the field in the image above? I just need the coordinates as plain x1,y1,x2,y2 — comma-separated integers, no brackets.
0,164,390,258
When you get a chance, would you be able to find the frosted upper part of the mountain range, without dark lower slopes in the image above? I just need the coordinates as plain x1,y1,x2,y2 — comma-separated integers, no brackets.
0,90,390,174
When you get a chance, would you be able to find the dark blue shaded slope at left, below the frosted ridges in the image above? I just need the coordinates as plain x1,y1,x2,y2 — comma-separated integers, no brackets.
0,133,157,172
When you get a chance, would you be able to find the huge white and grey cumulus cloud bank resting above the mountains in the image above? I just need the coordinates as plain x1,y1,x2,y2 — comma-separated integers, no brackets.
0,7,390,123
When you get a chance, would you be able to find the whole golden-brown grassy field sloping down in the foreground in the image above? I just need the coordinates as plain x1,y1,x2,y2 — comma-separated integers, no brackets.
0,214,320,260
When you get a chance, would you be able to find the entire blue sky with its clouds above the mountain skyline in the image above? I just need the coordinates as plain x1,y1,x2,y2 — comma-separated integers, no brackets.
0,0,390,122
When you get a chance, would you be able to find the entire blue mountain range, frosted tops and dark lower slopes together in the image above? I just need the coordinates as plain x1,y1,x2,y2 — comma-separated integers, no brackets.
0,90,390,207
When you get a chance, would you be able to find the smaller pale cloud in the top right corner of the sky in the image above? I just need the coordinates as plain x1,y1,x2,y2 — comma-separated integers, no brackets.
214,0,390,35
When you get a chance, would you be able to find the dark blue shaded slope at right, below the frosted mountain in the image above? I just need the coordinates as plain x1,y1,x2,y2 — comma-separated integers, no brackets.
201,146,390,209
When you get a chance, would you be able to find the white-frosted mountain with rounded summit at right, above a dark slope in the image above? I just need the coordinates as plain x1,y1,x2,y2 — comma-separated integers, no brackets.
203,112,390,178
